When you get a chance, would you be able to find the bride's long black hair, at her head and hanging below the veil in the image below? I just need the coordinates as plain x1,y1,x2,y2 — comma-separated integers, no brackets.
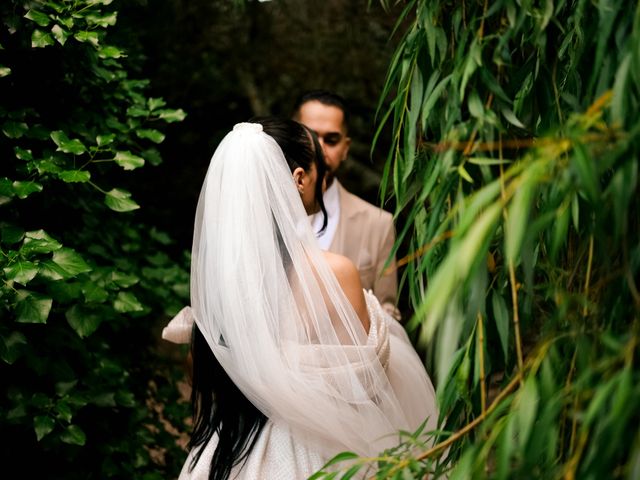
189,117,327,480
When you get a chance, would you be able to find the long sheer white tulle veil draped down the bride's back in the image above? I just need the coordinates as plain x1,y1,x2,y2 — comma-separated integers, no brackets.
191,123,432,455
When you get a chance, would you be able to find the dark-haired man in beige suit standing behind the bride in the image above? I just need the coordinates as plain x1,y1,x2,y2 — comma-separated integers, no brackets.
293,90,400,320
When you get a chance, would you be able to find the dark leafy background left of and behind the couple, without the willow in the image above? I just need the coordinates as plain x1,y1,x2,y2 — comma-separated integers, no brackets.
0,0,404,479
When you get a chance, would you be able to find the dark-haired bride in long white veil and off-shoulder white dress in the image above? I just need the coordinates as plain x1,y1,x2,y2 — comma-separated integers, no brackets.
163,118,438,480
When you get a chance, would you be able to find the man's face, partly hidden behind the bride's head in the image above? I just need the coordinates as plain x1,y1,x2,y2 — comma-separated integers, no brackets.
297,100,351,183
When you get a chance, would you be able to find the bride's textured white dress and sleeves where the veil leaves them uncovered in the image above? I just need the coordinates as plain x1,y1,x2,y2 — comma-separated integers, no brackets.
175,291,437,480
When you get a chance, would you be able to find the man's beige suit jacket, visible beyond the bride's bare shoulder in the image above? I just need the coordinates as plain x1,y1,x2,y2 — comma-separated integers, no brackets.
329,183,400,319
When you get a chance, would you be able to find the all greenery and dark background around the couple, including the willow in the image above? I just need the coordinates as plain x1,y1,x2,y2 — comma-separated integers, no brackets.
0,0,640,479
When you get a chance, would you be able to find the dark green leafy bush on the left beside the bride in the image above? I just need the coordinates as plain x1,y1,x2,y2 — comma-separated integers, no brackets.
0,0,188,479
